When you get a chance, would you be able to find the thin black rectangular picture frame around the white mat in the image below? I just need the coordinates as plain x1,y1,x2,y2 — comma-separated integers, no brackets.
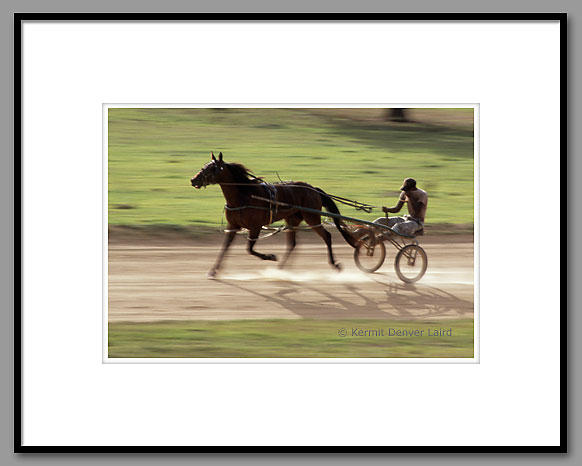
14,13,568,453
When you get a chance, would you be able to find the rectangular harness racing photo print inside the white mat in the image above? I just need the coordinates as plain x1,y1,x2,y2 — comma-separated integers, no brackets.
104,105,478,362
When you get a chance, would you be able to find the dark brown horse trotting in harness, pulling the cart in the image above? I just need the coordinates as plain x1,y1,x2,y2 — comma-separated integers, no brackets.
190,152,356,278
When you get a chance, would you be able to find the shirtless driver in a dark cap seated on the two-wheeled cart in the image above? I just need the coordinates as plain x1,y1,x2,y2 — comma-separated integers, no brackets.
374,178,428,236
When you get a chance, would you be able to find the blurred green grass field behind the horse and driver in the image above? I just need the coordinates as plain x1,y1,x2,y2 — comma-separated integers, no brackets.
108,108,473,227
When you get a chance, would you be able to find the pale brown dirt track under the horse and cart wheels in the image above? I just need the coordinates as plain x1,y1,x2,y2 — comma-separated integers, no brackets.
109,234,474,322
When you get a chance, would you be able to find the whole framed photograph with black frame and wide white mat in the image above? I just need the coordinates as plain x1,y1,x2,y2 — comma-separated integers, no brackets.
15,13,566,452
